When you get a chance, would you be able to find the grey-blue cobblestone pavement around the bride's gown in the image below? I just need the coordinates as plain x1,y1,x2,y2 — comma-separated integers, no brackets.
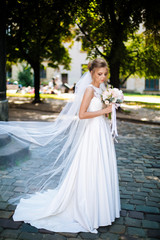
0,121,160,240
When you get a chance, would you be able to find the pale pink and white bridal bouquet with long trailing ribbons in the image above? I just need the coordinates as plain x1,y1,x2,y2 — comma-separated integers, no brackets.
101,88,124,140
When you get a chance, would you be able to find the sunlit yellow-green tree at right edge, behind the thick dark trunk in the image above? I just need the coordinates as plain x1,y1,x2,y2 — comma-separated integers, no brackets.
120,32,160,85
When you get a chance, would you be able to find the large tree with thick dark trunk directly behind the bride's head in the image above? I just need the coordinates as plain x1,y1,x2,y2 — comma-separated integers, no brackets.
77,0,142,87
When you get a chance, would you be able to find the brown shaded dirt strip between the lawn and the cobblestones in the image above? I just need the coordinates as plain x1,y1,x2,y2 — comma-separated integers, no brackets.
8,97,160,125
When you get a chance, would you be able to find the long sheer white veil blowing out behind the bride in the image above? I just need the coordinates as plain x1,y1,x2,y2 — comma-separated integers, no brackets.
0,71,105,202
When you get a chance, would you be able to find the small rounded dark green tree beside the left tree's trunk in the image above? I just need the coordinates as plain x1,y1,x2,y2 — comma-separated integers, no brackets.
18,65,33,87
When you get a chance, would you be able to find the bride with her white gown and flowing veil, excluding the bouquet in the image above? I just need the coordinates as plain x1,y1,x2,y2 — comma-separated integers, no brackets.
0,58,120,233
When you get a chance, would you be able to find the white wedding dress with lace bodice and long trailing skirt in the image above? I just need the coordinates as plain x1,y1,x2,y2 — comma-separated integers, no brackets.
13,84,120,233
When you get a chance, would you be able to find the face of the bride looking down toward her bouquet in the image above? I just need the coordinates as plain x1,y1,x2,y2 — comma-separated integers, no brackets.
91,67,108,84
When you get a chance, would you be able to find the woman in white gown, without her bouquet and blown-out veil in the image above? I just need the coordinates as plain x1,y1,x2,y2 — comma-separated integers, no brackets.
13,59,120,233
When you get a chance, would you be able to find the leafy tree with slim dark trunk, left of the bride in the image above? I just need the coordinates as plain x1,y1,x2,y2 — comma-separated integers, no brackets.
7,0,72,102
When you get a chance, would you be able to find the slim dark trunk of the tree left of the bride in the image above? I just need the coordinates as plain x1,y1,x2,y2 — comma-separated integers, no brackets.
32,61,41,103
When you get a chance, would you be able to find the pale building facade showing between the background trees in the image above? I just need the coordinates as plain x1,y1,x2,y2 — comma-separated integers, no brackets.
7,41,160,94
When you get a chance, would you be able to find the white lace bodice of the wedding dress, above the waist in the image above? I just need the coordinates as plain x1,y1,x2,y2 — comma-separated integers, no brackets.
88,84,103,112
